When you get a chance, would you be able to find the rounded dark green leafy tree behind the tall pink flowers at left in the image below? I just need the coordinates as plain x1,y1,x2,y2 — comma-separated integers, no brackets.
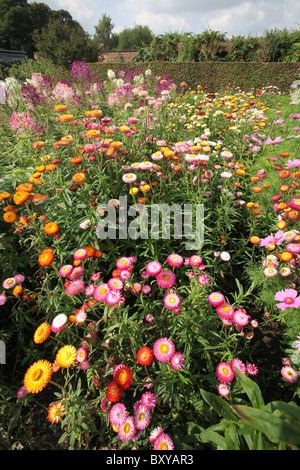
33,14,98,66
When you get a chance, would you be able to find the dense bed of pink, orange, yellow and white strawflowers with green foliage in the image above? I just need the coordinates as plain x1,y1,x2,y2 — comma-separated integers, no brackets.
0,62,300,450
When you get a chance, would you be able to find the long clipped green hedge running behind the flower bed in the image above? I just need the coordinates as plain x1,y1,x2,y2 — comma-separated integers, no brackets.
52,61,300,93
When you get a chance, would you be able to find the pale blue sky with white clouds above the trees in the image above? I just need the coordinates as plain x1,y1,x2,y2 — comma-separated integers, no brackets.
28,0,300,38
